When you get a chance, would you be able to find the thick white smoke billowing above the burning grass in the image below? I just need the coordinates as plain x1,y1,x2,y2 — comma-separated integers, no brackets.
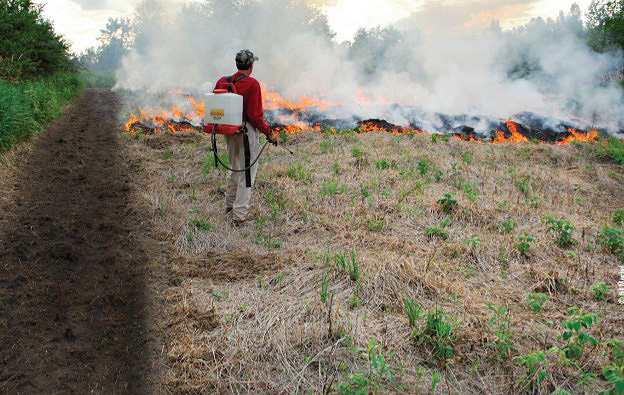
118,0,624,131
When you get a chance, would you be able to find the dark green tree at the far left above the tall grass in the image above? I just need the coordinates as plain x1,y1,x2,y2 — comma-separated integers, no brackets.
0,0,70,79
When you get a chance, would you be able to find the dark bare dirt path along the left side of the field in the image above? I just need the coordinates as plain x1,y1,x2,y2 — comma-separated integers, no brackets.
0,90,160,394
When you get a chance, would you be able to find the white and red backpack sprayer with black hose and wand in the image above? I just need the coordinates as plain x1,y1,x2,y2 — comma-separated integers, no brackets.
204,75,294,188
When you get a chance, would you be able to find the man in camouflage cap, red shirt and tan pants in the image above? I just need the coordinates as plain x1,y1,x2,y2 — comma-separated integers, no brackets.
215,49,276,226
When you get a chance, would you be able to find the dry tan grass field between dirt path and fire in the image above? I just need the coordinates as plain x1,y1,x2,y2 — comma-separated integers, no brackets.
127,129,624,394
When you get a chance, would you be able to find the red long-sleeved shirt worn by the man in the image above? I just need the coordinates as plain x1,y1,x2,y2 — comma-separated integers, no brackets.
215,71,271,136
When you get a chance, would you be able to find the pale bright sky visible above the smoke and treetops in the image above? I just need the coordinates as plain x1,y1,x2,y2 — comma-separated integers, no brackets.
35,0,591,53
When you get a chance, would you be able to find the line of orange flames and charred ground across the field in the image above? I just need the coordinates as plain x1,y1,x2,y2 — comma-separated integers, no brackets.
125,89,609,145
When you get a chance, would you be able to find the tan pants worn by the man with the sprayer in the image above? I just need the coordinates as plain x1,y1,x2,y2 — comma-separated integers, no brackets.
225,122,260,220
